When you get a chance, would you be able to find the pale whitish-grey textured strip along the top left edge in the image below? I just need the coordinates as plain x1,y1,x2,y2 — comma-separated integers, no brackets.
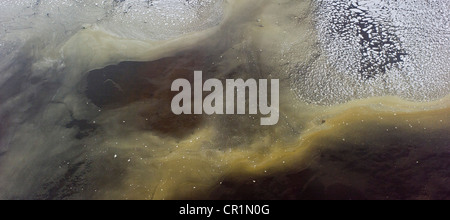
0,0,222,39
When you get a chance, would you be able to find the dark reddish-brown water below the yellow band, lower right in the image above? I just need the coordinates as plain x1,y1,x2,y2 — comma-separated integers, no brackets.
207,116,450,200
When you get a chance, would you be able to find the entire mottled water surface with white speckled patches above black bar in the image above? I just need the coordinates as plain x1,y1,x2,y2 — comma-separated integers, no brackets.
0,0,450,199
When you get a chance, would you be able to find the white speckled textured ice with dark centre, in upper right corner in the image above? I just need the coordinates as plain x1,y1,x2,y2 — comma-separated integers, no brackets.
294,0,450,104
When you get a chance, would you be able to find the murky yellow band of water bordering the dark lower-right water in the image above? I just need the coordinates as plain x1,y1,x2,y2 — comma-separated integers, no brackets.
83,87,450,199
